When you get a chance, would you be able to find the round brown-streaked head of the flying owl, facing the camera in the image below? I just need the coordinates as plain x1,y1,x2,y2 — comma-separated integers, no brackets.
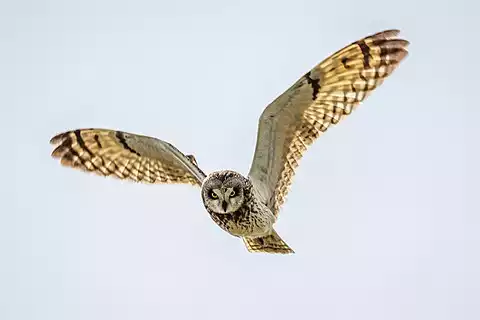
202,170,251,214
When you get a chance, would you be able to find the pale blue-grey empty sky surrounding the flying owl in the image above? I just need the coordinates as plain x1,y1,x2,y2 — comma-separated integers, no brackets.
0,0,480,320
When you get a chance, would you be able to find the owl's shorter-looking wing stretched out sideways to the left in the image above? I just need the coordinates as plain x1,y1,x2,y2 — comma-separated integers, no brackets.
50,129,205,185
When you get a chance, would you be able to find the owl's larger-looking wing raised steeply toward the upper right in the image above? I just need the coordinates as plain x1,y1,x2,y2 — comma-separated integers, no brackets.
249,30,409,215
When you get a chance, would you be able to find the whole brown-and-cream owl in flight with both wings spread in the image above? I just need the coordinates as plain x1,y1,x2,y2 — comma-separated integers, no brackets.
51,30,409,254
